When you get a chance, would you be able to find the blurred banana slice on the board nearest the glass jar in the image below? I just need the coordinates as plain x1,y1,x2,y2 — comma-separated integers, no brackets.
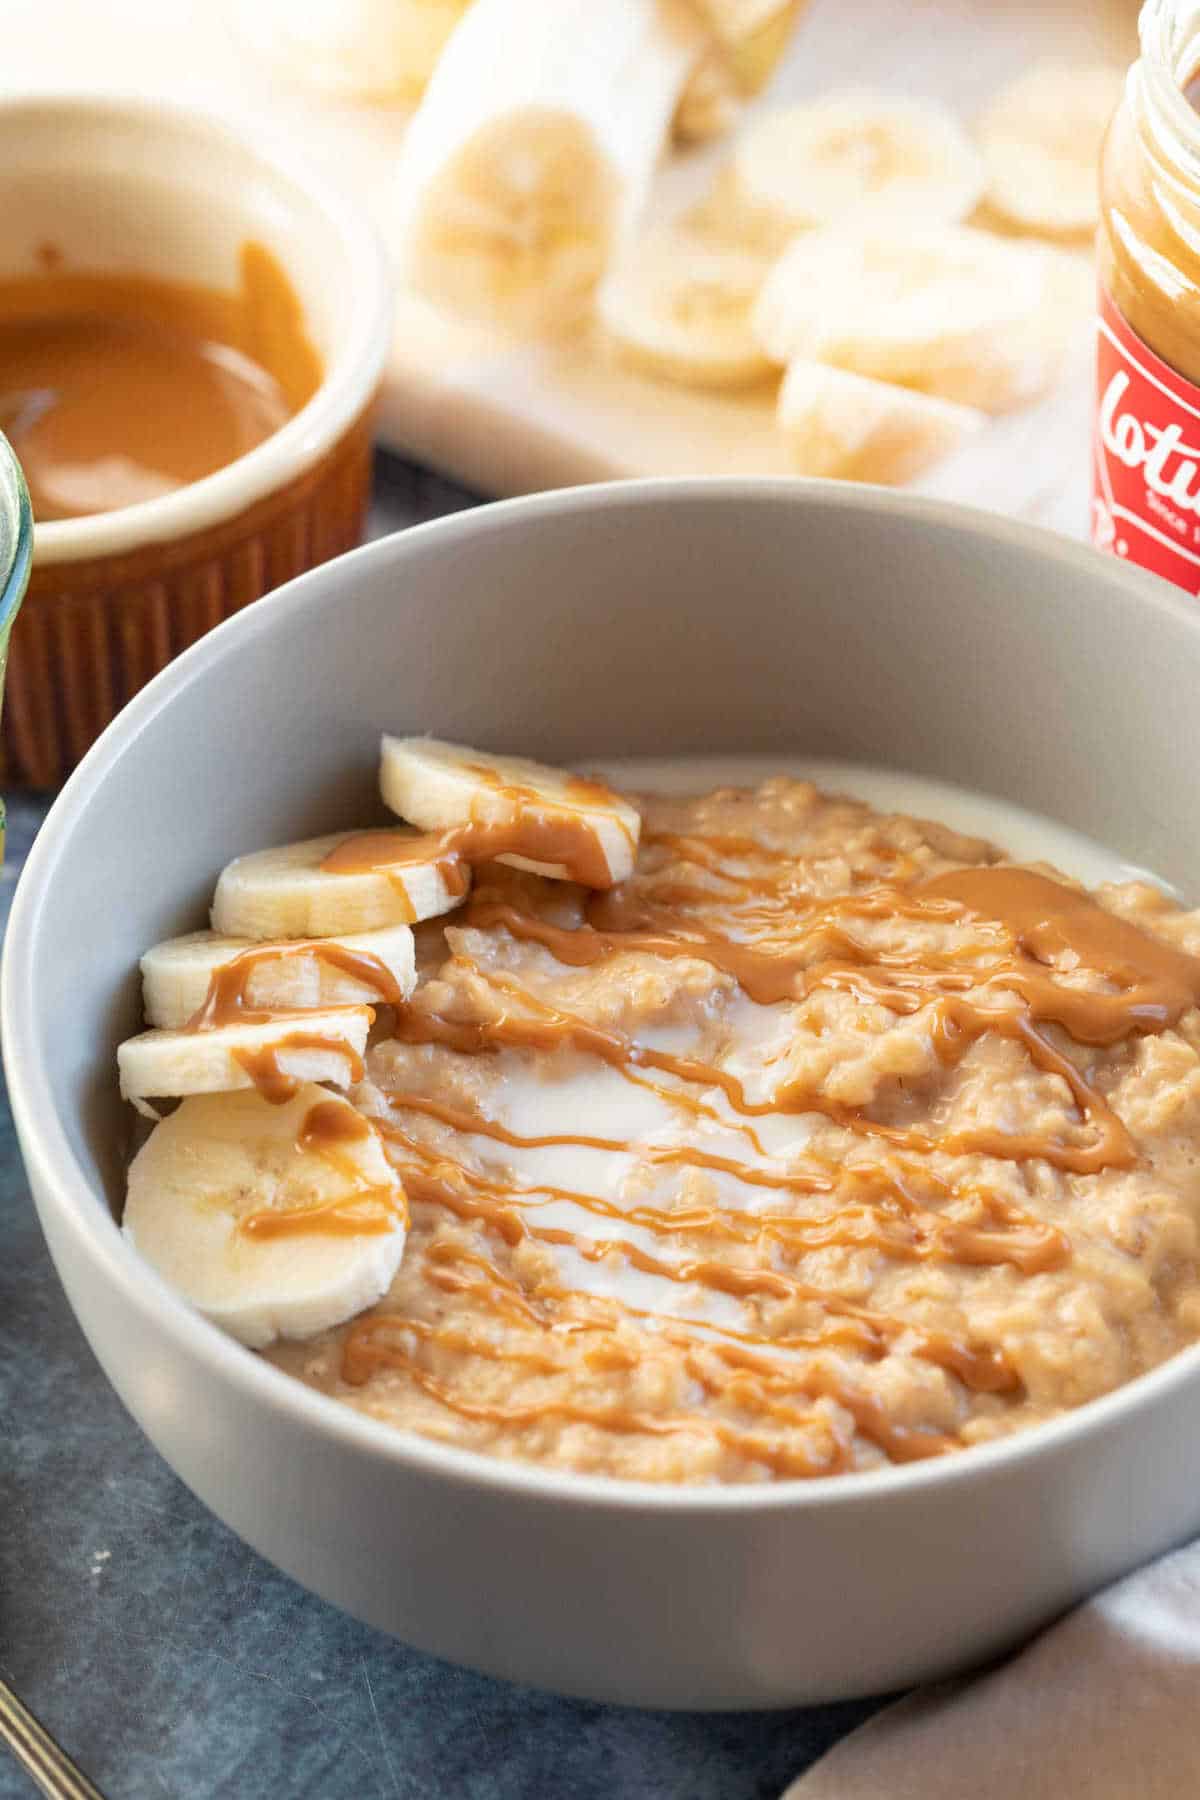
979,63,1124,238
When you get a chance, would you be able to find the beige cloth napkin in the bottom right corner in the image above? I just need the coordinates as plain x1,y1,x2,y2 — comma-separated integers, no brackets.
783,1541,1200,1800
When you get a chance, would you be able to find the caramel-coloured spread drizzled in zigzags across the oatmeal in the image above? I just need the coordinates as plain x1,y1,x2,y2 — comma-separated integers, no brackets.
302,788,1200,1476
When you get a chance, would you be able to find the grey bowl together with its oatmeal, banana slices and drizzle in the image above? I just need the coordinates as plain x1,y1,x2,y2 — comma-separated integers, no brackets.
18,482,1200,1708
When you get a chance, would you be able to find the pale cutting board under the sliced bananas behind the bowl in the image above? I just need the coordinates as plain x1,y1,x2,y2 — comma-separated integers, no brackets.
0,0,1137,536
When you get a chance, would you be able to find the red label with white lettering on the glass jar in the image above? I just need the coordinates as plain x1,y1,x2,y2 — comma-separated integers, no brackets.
1092,288,1200,594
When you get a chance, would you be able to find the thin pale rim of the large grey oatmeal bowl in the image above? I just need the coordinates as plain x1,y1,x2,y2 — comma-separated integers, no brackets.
9,475,1200,1516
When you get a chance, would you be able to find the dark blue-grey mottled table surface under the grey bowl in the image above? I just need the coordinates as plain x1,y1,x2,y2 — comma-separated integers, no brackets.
0,457,873,1800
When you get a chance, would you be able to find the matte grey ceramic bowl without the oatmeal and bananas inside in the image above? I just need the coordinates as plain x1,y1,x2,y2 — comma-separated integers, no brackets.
2,482,1200,1706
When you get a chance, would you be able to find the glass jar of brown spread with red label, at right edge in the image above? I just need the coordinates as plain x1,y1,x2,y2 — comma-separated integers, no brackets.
1092,0,1200,594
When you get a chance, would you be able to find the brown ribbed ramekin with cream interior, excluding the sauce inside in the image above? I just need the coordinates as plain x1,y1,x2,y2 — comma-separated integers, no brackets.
0,95,392,787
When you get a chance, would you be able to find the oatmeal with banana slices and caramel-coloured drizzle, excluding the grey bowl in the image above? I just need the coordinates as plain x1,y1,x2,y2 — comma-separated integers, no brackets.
121,740,1200,1483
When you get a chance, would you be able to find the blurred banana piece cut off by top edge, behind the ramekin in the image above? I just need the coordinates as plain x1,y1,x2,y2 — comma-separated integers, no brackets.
227,0,470,99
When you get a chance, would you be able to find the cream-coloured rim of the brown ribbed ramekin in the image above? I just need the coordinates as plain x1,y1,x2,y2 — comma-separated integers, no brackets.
0,88,394,569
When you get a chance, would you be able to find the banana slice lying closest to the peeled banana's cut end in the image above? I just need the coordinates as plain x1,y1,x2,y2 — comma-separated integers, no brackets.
596,227,772,387
